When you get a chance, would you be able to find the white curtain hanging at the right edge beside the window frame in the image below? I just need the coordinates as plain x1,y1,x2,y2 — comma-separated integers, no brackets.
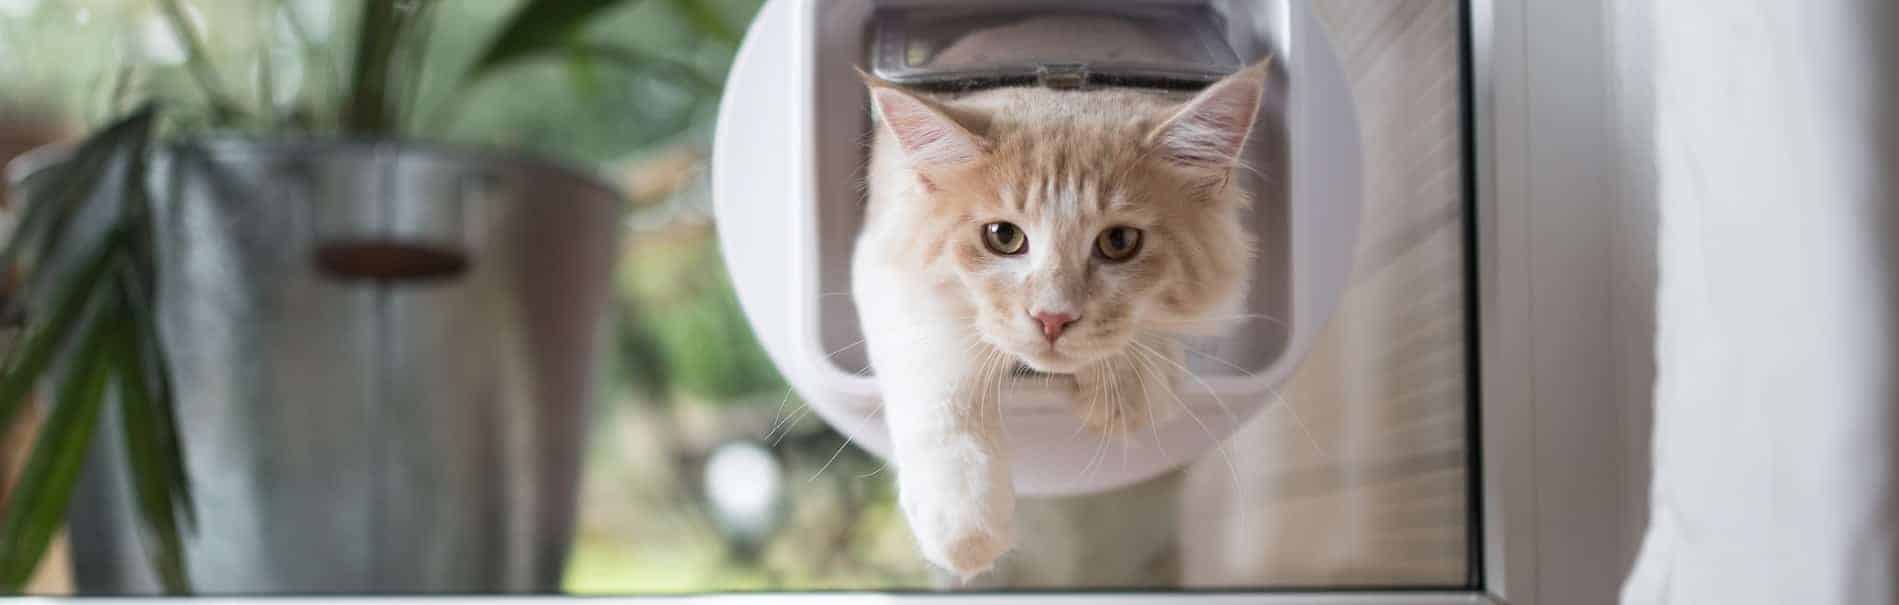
1616,0,1899,605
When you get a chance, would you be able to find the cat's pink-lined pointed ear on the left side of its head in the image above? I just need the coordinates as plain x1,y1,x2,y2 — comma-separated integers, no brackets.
858,72,989,169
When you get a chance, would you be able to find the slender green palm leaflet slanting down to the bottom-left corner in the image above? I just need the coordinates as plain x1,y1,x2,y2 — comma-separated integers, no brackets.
0,288,116,594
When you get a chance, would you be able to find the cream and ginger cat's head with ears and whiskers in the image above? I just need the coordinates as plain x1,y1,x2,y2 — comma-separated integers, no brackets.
870,63,1267,374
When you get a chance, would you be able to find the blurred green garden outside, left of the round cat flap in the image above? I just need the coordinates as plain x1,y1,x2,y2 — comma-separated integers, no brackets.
0,0,929,594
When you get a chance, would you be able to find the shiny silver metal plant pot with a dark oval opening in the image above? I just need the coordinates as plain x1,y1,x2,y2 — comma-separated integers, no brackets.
24,140,619,594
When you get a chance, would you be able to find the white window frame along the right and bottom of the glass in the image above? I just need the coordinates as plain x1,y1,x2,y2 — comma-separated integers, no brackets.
66,0,1650,605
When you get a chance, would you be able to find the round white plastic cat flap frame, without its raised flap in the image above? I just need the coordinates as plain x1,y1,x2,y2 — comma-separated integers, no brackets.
712,0,1360,495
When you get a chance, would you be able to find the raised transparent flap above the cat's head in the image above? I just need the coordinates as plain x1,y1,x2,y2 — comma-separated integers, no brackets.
870,4,1242,89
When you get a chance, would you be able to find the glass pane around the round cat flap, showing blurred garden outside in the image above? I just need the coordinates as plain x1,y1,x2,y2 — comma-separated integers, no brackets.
0,0,1472,594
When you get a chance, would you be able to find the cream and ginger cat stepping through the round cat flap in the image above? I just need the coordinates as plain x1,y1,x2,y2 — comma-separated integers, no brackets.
851,61,1267,580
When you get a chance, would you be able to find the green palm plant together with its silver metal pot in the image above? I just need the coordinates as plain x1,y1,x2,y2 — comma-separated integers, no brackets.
0,0,733,594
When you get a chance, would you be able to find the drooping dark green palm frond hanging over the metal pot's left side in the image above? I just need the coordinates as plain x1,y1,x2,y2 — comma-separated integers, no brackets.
0,108,190,594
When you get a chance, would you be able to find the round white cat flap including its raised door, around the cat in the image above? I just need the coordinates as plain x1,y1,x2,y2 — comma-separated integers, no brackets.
710,0,1362,495
